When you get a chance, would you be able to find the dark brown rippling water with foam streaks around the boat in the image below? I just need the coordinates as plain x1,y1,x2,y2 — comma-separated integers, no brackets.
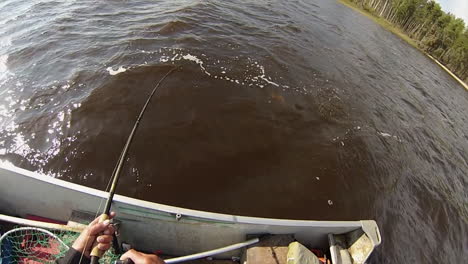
0,0,468,263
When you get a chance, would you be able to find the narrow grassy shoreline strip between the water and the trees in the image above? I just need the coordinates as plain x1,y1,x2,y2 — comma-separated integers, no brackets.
338,0,468,91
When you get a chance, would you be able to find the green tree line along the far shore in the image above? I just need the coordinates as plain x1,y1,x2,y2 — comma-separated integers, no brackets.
340,0,468,89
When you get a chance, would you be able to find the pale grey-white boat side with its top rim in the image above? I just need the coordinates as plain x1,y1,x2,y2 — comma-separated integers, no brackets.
0,164,380,257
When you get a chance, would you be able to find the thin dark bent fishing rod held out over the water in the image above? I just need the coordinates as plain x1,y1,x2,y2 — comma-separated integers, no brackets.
91,67,178,264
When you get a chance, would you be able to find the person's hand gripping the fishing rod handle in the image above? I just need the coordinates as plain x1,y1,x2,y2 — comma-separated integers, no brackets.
72,212,115,257
